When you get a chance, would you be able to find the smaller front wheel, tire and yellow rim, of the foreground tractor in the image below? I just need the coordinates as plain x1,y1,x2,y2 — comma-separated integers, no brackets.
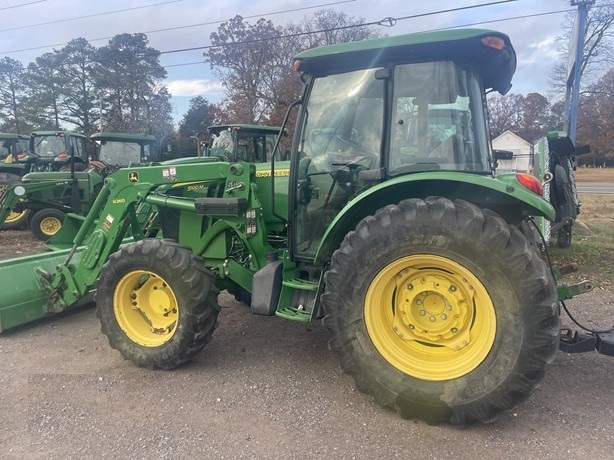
95,238,220,369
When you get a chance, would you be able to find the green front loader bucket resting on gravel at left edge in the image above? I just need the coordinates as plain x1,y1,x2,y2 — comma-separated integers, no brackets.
0,249,93,332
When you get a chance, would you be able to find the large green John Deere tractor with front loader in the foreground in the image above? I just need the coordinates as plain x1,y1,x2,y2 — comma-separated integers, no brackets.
0,29,600,425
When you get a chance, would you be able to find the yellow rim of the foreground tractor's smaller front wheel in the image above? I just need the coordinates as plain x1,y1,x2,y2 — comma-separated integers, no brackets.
113,270,179,347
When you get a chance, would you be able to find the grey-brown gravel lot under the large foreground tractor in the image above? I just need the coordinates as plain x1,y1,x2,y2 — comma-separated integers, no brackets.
0,231,614,459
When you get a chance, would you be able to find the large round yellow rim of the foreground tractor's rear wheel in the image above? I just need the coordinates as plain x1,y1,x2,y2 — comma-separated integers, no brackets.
364,254,497,381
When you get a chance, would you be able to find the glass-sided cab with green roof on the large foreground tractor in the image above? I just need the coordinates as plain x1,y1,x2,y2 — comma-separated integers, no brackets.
291,31,516,260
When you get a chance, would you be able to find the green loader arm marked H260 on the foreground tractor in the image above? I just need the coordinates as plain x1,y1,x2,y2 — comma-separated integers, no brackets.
38,162,236,312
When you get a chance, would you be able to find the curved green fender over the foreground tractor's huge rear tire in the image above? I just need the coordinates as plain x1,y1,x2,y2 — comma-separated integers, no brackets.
315,172,556,264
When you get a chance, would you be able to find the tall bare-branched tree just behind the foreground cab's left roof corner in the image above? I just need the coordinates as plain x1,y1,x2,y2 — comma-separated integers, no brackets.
204,10,377,125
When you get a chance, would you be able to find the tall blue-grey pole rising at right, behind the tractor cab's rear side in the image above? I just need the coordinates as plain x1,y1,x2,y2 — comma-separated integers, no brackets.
564,0,595,144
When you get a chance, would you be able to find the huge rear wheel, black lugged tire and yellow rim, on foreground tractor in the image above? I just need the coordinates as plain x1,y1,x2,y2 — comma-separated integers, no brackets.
322,198,560,425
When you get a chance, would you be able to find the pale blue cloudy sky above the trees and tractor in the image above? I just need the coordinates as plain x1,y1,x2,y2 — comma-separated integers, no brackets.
0,0,572,126
